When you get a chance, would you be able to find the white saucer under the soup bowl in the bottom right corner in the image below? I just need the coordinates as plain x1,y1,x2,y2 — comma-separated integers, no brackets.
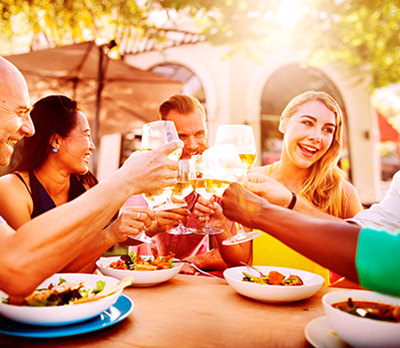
304,315,351,348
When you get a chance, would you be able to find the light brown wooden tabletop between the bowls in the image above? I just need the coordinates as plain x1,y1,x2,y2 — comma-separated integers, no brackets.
0,275,339,348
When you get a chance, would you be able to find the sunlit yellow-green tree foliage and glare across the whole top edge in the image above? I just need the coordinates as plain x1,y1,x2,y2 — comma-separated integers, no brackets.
0,0,400,87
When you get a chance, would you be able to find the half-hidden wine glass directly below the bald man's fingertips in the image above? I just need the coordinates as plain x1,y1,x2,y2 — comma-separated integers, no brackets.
167,159,195,235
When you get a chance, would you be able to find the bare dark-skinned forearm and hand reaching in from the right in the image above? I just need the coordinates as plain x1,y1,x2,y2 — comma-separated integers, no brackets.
222,183,360,283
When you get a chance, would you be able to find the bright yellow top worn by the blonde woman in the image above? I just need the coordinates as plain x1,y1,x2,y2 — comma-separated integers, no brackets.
253,163,330,286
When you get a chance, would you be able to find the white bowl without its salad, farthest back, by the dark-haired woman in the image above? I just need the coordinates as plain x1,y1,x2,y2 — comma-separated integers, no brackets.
96,256,183,286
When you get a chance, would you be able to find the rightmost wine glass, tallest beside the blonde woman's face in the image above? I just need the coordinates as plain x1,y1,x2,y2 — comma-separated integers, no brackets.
215,124,262,245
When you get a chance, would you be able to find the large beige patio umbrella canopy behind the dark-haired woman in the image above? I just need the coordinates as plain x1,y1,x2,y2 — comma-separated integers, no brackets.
5,41,182,141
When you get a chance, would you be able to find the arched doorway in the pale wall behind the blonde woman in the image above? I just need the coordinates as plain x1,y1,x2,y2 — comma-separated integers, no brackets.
260,64,351,180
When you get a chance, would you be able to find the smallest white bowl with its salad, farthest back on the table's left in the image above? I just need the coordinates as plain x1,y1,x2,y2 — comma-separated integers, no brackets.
96,248,183,287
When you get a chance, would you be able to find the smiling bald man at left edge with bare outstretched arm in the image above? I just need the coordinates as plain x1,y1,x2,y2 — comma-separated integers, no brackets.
0,57,183,296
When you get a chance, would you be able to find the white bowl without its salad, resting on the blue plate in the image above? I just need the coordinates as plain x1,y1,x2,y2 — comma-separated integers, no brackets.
0,273,122,326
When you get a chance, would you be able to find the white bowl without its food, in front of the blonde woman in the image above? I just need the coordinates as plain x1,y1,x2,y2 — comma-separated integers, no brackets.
224,266,324,303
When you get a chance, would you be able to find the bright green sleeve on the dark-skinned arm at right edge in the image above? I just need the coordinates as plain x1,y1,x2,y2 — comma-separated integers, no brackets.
356,228,400,297
